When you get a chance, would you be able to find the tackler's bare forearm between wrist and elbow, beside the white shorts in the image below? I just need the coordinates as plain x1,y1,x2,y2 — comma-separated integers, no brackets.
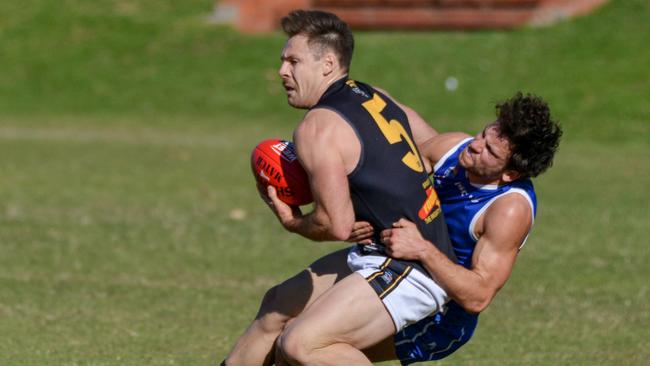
419,244,494,313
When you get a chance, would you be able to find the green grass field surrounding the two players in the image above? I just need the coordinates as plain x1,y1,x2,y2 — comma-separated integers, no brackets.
0,0,650,366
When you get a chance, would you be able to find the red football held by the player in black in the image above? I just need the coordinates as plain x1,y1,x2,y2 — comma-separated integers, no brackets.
251,139,314,206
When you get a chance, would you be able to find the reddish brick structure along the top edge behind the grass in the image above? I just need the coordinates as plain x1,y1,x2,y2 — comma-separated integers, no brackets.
211,0,607,32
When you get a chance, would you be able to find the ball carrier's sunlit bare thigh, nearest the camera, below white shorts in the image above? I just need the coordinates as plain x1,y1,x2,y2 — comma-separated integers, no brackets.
283,274,395,349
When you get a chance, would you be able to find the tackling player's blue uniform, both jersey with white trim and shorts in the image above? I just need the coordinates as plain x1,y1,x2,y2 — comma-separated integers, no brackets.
394,137,537,365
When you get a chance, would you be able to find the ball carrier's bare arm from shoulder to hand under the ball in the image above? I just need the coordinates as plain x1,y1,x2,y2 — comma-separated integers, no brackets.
274,109,360,241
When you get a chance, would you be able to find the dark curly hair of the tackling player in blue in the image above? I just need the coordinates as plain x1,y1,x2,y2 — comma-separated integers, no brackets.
496,92,562,177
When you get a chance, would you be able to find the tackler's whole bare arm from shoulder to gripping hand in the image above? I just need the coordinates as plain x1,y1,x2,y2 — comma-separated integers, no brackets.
382,194,532,313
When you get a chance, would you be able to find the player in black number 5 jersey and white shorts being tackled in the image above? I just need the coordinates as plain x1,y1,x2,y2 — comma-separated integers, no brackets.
224,11,456,365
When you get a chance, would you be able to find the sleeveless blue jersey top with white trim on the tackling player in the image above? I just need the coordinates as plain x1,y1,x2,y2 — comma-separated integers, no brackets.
433,137,537,268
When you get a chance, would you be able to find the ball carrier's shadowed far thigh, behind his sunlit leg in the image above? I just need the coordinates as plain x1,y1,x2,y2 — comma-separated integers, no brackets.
260,248,351,317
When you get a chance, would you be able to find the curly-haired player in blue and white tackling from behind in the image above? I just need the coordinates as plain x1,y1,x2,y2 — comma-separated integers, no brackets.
351,93,562,365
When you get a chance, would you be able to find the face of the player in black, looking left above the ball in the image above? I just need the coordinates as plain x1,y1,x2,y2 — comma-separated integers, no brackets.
278,34,324,108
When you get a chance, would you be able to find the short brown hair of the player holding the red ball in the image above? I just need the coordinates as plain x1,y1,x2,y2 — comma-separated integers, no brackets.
281,10,354,71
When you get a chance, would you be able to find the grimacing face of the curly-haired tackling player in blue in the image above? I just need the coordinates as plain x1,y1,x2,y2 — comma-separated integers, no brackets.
459,123,511,184
